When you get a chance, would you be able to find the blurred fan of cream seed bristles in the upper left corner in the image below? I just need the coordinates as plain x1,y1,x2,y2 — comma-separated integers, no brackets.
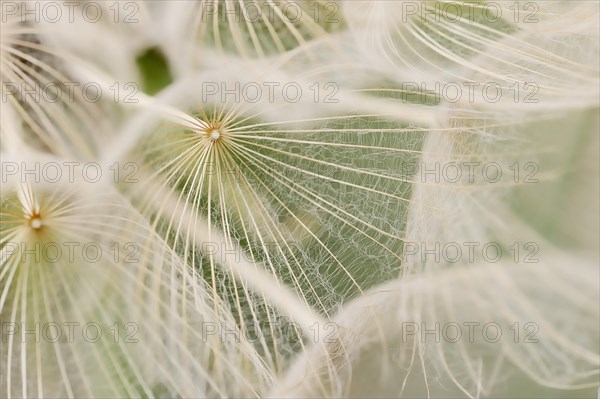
0,8,103,156
